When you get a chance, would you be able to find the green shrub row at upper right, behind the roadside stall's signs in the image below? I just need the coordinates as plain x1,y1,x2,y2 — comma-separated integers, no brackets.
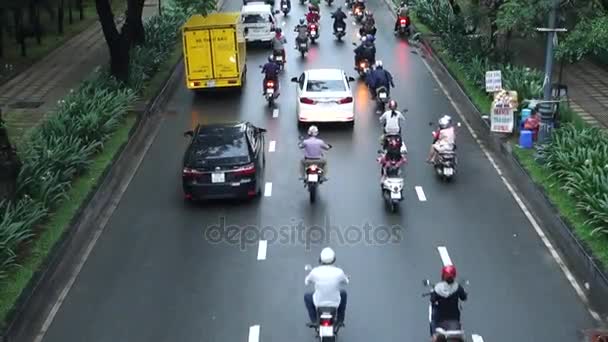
413,0,543,107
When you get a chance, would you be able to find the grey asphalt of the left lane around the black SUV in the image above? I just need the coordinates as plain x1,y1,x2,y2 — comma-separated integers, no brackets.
40,44,290,341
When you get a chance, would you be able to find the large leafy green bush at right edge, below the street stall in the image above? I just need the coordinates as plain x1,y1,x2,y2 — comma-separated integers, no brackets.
538,124,608,236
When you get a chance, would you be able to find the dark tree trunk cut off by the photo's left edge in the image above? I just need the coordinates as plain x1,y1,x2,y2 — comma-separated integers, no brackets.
0,110,21,201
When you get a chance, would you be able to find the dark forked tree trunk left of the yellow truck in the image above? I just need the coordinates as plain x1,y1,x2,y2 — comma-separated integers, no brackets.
95,0,132,82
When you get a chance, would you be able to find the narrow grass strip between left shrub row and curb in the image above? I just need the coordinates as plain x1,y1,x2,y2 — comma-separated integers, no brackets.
0,44,182,327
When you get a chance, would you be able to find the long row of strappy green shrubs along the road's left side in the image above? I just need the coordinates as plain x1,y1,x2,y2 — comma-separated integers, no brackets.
0,4,188,279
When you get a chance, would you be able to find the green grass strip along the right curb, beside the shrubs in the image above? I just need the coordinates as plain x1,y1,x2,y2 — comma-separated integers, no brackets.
412,16,608,272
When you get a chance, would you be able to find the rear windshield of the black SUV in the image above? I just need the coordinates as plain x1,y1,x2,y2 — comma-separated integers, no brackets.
192,131,249,167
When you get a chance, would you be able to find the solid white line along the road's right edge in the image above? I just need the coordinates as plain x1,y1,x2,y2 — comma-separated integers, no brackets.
422,44,601,322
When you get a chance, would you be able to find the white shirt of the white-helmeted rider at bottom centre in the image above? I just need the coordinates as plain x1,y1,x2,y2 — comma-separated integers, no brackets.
304,265,348,308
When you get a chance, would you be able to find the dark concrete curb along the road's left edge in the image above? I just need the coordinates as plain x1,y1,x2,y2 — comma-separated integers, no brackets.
0,45,183,342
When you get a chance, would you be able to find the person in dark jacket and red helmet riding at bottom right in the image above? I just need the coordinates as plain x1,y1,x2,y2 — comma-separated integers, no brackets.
431,265,468,336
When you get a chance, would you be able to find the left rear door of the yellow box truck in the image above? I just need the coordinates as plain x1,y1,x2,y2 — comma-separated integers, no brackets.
184,29,213,80
